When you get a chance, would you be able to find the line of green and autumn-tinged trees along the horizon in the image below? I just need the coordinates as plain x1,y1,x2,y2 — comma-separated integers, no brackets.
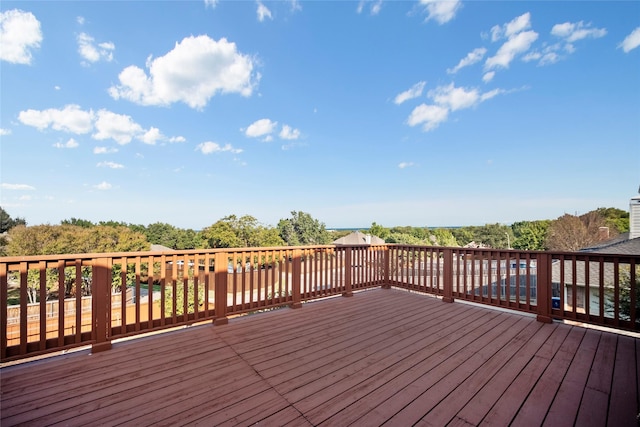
0,207,629,256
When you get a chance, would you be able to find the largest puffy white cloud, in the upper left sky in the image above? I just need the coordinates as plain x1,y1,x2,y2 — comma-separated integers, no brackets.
109,35,260,109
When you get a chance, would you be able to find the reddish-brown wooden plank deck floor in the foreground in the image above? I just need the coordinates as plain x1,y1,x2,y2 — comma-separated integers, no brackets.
0,289,640,426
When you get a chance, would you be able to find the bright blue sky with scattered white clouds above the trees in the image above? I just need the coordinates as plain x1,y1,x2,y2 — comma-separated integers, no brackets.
0,1,640,229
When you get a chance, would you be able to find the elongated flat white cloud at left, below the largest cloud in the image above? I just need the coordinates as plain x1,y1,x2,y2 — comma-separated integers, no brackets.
18,104,94,134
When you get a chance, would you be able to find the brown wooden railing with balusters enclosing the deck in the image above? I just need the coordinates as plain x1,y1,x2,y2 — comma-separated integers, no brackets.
0,245,640,361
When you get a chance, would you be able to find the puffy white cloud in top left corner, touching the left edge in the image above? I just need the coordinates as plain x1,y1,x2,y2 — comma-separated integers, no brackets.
0,9,42,65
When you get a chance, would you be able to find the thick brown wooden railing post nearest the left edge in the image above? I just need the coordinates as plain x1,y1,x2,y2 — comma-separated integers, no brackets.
91,258,113,353
